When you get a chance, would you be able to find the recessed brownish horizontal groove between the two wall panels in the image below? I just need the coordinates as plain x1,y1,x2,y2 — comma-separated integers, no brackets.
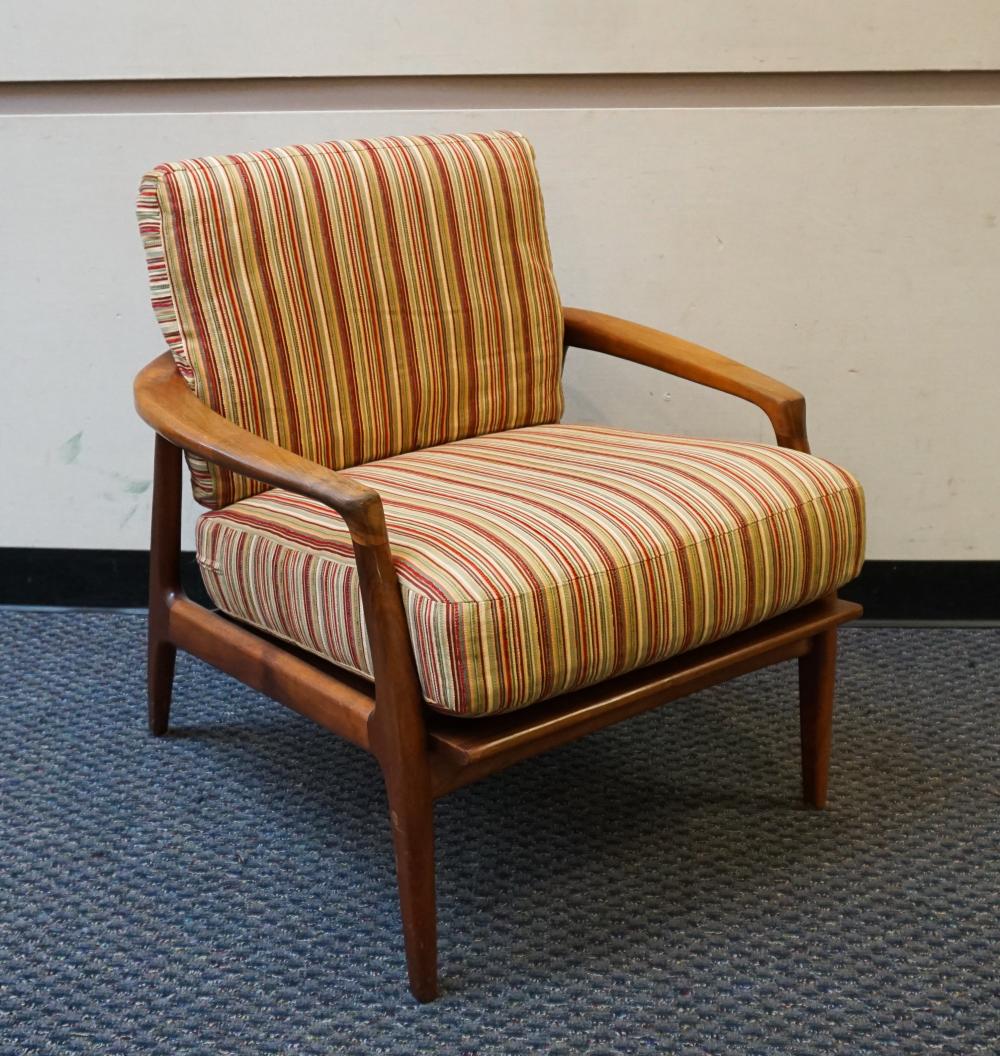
0,70,1000,114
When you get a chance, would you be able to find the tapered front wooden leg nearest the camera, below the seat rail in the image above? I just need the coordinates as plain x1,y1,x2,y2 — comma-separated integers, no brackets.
385,774,437,1001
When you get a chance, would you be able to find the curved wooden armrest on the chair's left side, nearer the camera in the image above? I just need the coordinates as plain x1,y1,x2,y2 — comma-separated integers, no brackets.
129,353,386,545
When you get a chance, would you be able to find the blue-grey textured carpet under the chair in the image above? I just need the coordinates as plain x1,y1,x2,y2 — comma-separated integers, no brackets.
0,610,1000,1056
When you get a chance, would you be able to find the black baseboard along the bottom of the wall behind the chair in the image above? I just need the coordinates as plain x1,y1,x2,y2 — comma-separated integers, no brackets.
0,547,1000,623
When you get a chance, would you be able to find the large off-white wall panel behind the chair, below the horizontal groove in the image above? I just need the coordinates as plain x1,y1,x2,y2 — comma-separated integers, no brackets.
0,108,1000,559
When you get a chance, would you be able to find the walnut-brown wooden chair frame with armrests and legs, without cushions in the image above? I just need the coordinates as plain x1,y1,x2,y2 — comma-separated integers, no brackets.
135,308,861,1001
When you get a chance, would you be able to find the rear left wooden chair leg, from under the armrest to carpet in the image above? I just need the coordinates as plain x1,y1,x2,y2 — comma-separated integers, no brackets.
147,436,181,737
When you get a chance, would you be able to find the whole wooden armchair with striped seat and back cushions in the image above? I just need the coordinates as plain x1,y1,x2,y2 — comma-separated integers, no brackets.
135,132,864,1001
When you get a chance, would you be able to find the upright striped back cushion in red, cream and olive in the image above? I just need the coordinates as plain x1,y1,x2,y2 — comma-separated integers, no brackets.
138,132,563,508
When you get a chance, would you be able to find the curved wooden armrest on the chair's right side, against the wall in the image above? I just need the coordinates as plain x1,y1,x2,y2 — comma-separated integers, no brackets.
563,308,809,451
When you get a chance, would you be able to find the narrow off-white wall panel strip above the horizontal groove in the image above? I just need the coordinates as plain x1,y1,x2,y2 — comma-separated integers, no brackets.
0,0,1000,80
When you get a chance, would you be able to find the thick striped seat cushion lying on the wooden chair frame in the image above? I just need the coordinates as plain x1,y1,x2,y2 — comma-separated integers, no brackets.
197,425,864,715
